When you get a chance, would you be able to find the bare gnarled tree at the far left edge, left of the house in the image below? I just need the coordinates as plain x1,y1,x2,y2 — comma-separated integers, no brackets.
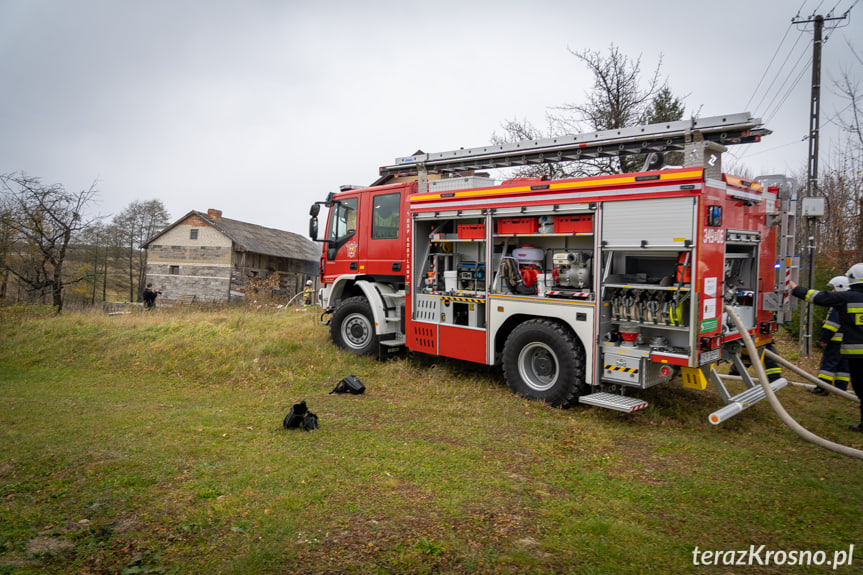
0,173,98,313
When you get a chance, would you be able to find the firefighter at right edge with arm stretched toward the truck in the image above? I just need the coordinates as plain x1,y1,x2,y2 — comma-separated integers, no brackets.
789,263,863,433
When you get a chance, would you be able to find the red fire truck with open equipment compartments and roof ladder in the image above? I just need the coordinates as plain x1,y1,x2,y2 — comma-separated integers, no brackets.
310,113,796,423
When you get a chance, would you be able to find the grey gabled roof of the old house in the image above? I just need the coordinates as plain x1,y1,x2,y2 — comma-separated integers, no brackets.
144,210,321,262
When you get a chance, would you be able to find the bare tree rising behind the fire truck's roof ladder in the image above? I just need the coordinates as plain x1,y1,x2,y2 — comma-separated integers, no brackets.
491,44,684,177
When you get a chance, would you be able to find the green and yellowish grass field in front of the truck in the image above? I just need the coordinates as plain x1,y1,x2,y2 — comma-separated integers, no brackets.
0,309,863,574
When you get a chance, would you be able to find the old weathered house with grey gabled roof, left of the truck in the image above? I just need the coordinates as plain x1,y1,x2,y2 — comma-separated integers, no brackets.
144,209,321,302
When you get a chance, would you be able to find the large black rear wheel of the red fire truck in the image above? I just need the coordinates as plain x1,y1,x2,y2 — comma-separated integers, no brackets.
503,319,584,407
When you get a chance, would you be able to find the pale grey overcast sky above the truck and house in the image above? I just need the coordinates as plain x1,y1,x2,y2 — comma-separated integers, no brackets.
0,0,863,234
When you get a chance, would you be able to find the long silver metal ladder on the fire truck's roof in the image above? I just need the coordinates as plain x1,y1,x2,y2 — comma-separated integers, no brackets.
380,112,771,176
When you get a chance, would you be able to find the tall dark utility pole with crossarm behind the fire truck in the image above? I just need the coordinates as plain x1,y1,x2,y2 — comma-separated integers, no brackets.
791,9,850,357
